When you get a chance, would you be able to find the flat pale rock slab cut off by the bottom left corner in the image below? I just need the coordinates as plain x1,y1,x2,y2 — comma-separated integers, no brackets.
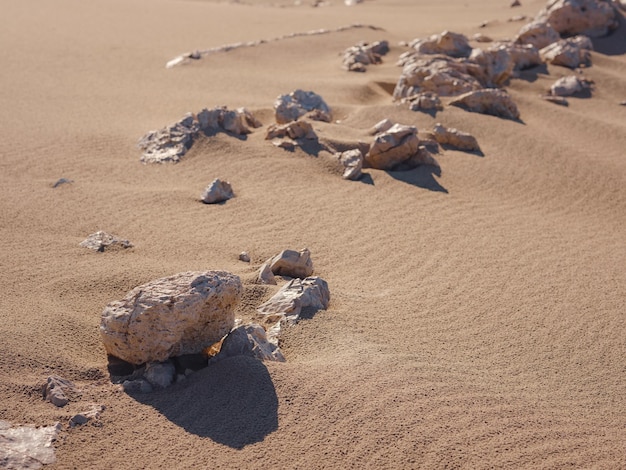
0,420,61,470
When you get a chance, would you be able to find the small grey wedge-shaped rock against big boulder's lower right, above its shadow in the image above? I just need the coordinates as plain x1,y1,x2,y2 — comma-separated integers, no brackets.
216,324,285,362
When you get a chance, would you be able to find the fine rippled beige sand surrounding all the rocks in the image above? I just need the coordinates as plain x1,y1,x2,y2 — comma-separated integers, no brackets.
0,0,626,469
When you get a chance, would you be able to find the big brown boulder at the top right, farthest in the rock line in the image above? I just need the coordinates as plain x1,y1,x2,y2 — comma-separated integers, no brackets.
538,0,618,37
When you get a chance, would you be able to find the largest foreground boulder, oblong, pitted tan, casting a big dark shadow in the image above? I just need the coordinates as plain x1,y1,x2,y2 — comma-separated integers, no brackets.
100,271,243,365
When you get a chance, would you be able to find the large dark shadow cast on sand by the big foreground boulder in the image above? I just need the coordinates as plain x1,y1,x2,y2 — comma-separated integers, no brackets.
132,356,278,449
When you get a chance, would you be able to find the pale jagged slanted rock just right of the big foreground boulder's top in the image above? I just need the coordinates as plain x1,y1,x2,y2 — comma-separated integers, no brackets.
257,276,330,323
